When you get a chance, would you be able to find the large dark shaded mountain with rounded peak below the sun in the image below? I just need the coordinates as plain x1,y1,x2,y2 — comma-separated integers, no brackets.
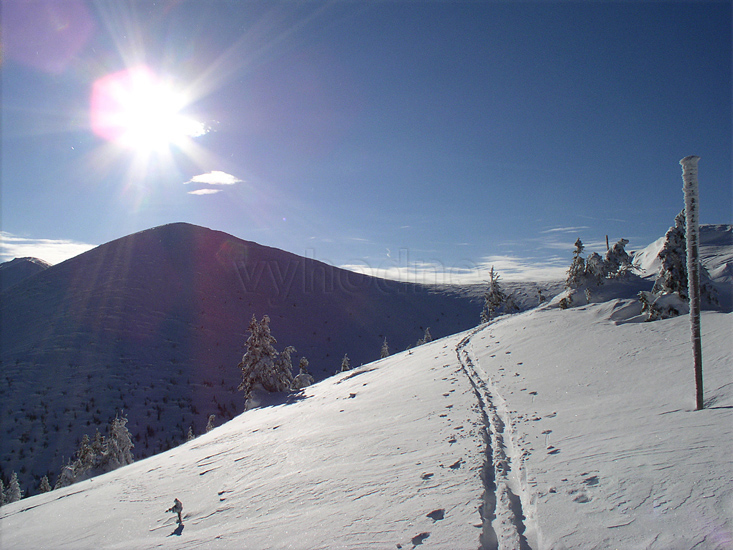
0,223,492,494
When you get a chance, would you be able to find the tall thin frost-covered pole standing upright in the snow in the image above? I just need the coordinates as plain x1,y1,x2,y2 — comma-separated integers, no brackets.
680,155,704,411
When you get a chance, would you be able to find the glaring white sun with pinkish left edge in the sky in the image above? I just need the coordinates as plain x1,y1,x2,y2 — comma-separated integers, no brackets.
91,66,206,153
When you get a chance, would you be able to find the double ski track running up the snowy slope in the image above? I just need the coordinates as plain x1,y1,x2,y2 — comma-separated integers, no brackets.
456,327,532,550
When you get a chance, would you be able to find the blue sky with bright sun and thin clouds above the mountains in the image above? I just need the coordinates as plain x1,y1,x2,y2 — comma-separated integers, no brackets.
1,0,733,282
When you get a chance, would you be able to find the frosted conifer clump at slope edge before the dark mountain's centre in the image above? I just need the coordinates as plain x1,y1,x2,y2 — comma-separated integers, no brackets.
238,315,295,400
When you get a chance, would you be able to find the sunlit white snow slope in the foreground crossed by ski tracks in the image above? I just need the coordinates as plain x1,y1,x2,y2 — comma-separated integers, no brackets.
0,306,733,550
